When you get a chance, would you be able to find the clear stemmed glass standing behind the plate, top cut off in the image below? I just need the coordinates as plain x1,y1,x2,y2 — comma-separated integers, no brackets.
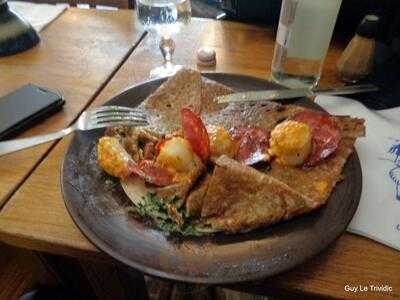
136,0,192,77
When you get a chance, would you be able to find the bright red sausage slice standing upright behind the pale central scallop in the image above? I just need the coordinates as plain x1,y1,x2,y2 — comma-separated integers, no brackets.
181,108,210,161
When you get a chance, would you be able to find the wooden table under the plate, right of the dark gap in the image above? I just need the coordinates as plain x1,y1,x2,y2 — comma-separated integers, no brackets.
0,20,400,299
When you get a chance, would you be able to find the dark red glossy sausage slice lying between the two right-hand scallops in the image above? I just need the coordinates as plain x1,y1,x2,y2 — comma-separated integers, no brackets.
231,126,269,165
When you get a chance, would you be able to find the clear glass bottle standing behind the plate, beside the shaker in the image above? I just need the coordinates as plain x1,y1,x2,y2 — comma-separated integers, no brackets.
271,0,342,88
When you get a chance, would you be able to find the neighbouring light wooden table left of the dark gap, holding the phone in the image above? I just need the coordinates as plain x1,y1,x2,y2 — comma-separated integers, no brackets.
0,8,142,207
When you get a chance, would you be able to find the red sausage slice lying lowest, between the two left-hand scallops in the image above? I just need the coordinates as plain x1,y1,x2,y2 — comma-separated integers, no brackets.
130,160,174,186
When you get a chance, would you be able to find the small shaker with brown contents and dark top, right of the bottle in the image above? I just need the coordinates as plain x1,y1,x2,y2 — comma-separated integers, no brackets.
337,15,379,83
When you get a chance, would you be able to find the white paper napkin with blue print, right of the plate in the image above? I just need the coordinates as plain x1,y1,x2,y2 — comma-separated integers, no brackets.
316,96,400,250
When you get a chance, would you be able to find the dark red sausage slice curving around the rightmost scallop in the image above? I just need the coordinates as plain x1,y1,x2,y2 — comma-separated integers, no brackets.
291,110,341,167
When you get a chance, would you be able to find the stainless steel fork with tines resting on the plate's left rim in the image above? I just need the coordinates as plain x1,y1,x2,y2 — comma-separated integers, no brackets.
0,106,148,156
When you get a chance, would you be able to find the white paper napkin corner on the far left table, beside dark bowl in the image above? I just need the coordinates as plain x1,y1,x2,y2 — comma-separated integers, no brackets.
8,1,69,32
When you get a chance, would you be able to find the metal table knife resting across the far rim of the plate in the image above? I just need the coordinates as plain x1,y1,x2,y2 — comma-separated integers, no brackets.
215,84,379,103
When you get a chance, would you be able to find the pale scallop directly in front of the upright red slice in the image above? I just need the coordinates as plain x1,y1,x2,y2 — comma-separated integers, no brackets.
156,137,196,173
